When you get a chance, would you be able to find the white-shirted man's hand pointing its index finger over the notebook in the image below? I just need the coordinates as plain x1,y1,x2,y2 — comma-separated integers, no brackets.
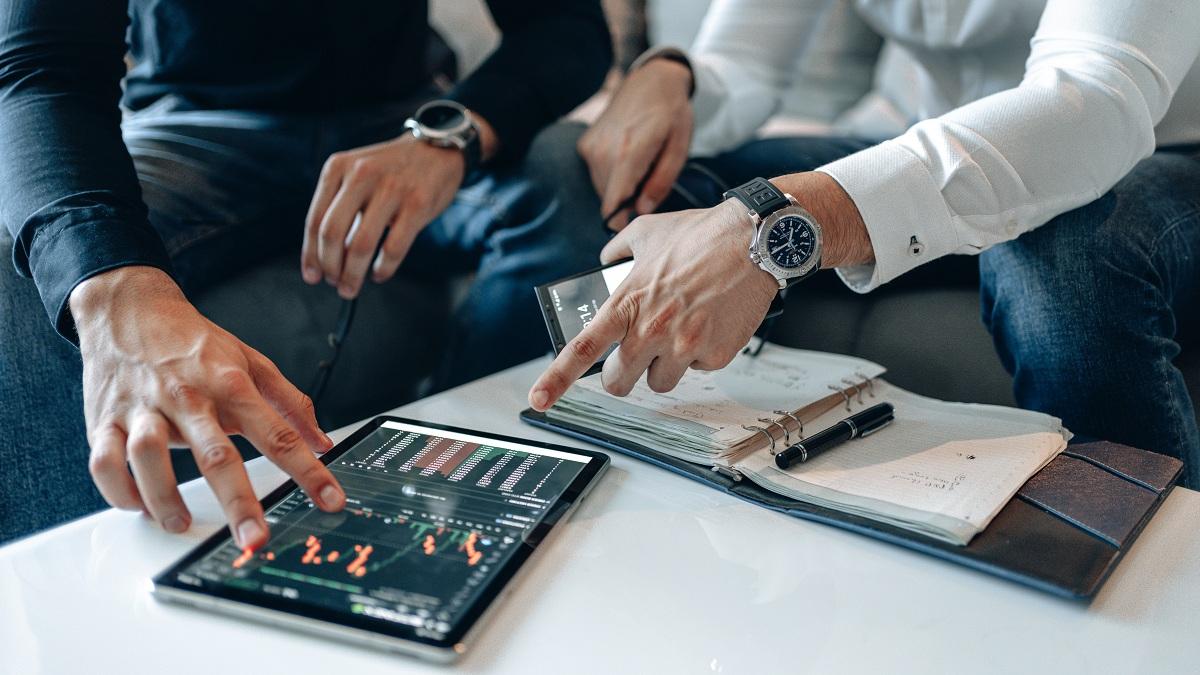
529,202,779,411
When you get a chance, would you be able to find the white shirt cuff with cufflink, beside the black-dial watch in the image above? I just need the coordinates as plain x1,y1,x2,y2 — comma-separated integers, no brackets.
816,141,959,293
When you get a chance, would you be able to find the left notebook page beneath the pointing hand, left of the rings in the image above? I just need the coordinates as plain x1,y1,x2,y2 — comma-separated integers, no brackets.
564,345,883,447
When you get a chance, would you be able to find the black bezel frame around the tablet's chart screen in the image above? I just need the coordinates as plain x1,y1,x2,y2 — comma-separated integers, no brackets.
154,416,610,653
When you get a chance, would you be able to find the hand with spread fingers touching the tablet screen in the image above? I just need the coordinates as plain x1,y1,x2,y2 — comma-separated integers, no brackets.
70,267,346,548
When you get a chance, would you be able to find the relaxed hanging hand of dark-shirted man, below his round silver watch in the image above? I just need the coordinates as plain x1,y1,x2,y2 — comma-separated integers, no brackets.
300,135,466,299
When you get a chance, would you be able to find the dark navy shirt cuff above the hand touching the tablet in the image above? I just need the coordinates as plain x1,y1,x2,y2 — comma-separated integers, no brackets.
21,209,172,345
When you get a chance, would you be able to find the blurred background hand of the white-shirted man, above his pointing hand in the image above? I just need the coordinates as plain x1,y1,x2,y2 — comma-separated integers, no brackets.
577,59,692,231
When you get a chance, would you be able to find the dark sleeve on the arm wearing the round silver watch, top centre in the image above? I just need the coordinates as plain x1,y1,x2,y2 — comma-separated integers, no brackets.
450,0,612,159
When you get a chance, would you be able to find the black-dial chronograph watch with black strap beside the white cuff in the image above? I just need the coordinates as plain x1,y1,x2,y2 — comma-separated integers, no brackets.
725,178,821,289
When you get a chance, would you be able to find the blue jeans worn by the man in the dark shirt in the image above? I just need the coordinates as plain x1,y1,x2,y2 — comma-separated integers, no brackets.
0,97,606,543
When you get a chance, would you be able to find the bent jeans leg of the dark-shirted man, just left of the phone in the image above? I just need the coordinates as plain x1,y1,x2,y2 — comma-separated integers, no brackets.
388,123,608,389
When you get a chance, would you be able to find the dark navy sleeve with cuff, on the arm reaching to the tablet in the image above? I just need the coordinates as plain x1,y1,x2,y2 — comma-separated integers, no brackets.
0,0,169,340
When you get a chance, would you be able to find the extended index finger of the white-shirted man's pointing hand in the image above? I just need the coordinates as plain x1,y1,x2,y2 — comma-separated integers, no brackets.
529,297,629,412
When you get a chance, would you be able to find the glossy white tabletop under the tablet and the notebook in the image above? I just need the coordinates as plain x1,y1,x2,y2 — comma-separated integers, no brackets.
0,362,1200,675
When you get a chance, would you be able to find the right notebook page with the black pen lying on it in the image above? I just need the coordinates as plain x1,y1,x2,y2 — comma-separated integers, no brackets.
737,381,1069,543
